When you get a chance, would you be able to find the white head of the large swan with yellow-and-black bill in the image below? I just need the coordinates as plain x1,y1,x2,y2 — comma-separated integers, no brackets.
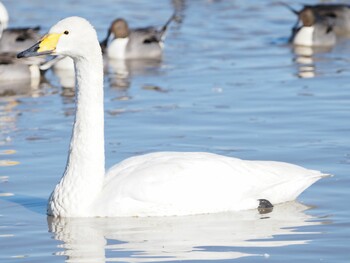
17,16,99,58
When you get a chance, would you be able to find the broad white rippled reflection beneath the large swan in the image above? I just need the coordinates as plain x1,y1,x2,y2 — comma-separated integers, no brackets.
48,202,321,263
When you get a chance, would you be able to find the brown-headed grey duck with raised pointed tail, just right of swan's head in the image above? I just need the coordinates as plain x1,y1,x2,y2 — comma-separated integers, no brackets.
101,14,175,59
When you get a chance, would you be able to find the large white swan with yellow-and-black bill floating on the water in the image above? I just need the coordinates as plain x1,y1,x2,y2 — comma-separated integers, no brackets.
18,17,325,217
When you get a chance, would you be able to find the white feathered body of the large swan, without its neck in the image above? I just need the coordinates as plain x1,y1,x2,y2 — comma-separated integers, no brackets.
96,152,322,216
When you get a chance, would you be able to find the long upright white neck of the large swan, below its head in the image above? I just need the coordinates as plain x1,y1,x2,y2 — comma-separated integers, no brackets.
48,48,105,216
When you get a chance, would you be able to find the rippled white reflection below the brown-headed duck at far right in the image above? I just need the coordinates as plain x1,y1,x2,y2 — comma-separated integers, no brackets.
293,46,332,78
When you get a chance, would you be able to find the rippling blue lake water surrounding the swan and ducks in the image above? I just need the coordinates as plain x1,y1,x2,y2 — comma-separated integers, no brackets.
0,0,350,263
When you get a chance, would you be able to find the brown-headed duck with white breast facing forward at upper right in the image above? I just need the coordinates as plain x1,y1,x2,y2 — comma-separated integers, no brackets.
291,9,337,47
